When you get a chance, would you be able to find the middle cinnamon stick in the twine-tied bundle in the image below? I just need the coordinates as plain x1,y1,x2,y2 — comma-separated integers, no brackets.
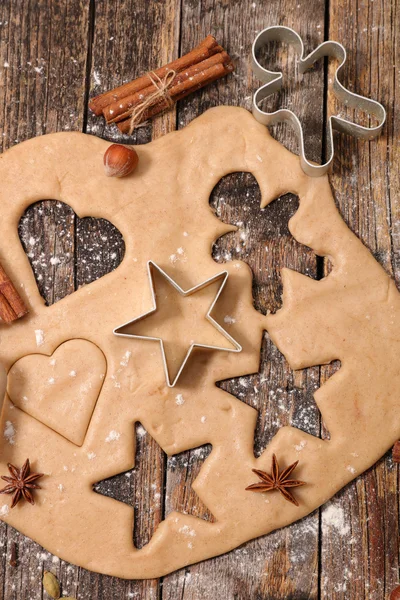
103,51,231,123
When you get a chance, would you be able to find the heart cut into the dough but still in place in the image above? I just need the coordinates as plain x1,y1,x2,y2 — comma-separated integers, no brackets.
8,339,107,446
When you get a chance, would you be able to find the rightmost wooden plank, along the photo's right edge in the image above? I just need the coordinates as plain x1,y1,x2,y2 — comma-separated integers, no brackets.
321,0,400,600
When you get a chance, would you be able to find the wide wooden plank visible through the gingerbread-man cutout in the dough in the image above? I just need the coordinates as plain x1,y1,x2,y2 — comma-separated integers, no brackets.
163,0,324,600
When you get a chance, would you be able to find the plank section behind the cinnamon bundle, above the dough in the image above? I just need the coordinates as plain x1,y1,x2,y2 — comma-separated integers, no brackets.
87,0,180,144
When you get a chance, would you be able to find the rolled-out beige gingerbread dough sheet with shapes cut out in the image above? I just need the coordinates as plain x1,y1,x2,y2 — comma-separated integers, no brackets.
0,107,400,578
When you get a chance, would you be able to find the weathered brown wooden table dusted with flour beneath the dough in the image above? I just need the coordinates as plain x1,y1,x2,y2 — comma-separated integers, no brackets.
0,0,400,600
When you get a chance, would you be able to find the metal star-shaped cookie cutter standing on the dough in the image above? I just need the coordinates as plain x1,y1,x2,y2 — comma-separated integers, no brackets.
113,260,242,388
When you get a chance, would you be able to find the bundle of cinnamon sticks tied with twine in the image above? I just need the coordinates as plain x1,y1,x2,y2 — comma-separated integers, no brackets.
89,35,234,133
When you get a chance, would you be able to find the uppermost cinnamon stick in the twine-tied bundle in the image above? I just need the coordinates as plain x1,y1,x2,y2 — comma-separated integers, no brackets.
89,35,222,116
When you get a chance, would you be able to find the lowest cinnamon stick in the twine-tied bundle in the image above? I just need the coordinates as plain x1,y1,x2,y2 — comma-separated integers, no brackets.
116,63,234,133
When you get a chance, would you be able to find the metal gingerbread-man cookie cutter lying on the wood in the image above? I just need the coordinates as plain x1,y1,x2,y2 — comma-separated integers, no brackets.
252,26,386,177
